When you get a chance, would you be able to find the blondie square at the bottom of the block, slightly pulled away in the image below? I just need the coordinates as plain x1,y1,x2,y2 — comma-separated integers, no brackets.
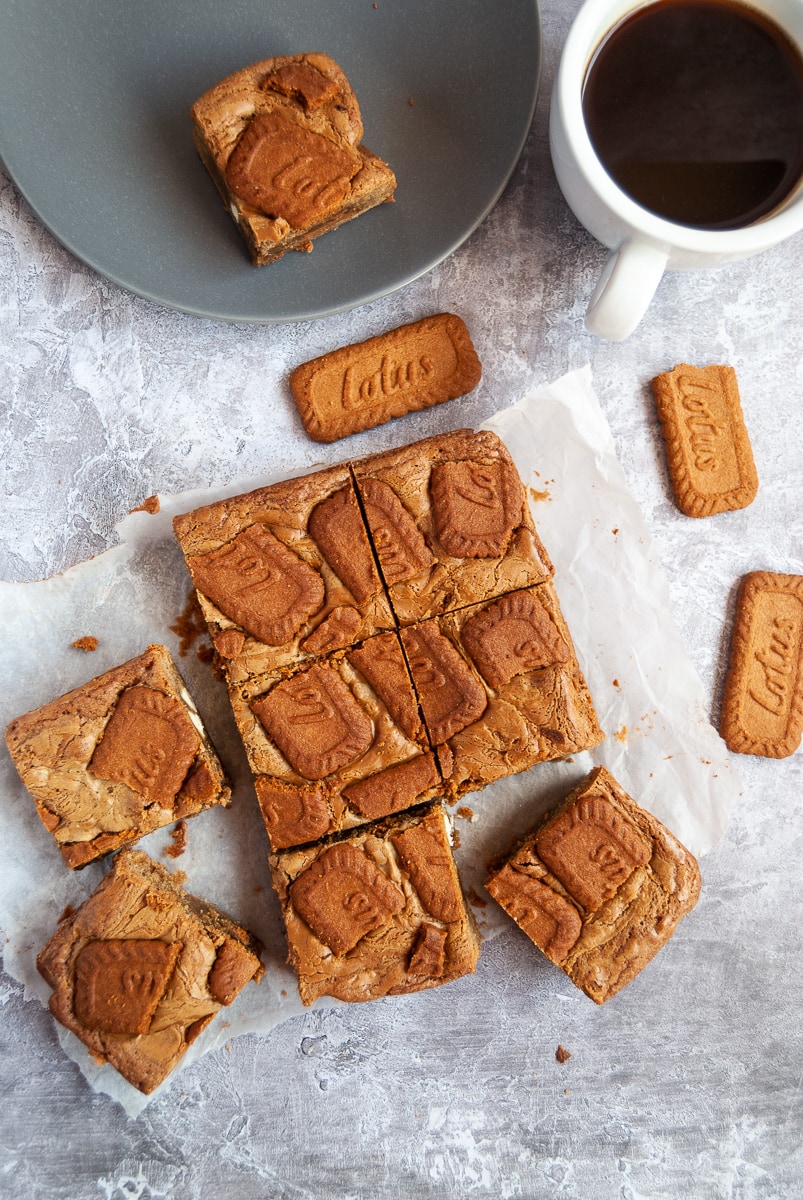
270,804,480,1004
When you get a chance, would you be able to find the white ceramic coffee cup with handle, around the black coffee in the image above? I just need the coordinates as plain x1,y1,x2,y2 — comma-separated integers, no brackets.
550,0,803,342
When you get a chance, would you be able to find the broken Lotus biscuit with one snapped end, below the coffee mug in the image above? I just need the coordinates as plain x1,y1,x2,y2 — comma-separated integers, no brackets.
652,362,759,517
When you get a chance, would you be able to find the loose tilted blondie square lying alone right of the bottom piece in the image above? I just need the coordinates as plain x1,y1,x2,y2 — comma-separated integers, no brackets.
486,767,700,1004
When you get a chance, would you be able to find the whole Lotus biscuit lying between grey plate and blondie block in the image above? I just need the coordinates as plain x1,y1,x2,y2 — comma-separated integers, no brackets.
289,312,481,442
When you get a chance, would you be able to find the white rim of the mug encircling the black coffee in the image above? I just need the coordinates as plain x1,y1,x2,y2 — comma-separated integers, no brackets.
557,0,803,254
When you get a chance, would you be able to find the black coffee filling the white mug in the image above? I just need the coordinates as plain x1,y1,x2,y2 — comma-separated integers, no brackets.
583,0,803,229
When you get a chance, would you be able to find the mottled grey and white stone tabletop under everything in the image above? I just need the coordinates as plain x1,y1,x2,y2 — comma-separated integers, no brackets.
0,0,803,1200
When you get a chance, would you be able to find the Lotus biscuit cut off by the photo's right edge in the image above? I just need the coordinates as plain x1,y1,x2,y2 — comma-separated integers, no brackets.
719,571,803,758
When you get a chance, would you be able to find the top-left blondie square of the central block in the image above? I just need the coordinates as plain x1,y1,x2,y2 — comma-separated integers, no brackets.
173,466,394,686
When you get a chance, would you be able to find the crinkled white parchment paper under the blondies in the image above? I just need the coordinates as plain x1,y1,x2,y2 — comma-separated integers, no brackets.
0,368,739,1115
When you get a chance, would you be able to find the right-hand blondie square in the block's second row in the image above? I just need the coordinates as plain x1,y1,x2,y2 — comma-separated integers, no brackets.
401,583,603,799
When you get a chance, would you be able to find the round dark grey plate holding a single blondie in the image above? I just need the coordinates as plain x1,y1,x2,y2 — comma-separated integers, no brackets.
0,0,540,322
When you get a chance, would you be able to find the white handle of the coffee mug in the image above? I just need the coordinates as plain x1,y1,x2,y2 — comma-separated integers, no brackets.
586,241,669,342
